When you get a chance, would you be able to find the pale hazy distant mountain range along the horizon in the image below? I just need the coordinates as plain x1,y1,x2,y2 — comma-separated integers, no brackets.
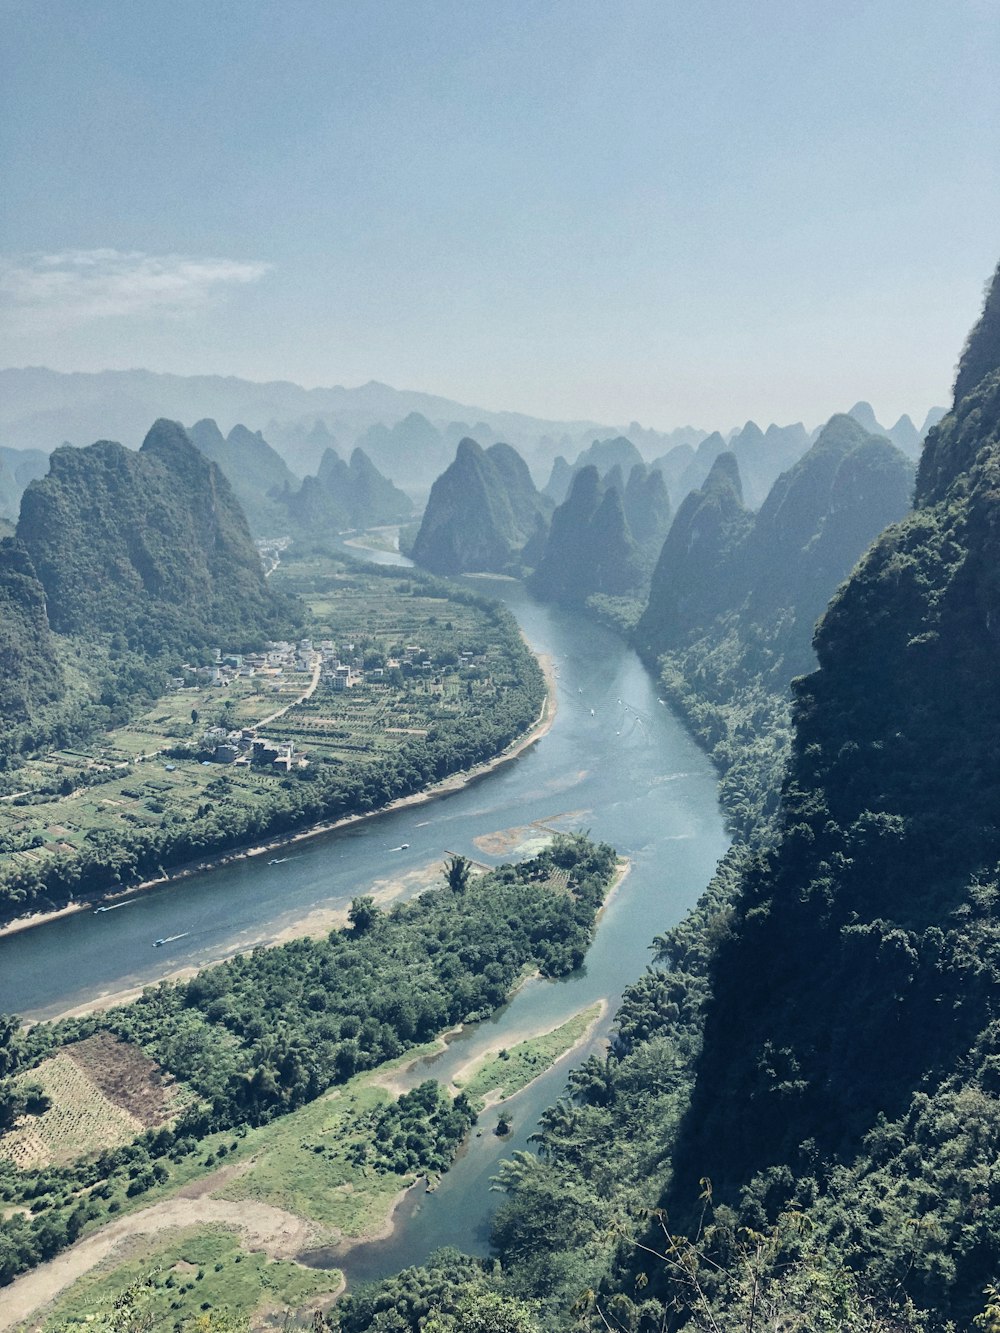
0,368,944,501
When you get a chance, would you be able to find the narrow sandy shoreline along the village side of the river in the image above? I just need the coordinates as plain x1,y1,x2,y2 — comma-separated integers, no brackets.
0,653,559,949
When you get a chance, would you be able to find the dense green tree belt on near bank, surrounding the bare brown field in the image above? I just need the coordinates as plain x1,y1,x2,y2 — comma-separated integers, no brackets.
0,836,615,1281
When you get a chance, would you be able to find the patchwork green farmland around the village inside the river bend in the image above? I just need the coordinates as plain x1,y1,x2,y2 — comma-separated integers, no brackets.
0,556,533,888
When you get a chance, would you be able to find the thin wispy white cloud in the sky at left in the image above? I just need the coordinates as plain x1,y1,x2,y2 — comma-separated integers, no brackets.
0,249,271,328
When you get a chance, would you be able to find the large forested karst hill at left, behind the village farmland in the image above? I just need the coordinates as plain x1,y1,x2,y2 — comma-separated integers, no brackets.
17,421,289,652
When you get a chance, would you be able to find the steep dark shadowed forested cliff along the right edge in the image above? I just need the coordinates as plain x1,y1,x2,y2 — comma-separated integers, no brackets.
658,259,1000,1326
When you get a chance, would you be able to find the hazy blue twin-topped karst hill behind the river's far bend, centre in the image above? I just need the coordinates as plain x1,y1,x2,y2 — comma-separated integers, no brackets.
412,439,549,573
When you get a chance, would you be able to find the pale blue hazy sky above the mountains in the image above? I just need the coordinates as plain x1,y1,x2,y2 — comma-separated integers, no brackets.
0,0,1000,428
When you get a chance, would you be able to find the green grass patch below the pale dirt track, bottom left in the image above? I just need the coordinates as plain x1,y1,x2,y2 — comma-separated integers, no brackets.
32,1226,340,1333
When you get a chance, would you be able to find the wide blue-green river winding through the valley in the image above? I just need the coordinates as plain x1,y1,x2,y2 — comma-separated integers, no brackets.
0,580,728,1282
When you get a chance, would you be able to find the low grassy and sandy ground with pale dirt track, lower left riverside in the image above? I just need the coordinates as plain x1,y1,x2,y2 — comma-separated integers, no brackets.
0,1002,608,1333
